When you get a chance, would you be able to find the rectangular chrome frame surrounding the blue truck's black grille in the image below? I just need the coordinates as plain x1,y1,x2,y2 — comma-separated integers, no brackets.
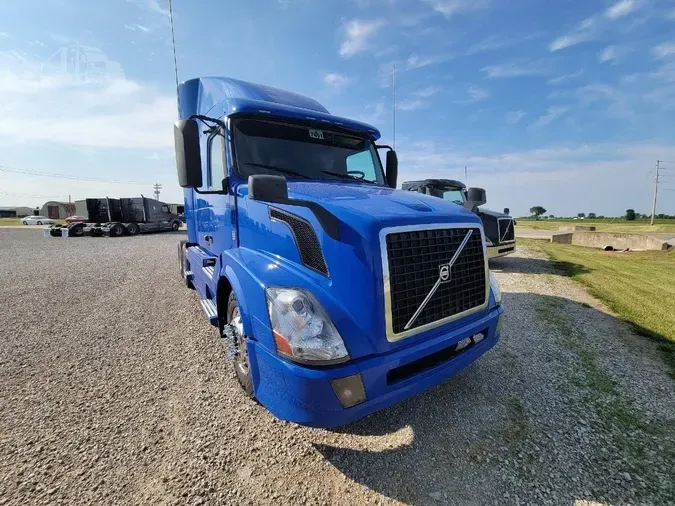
379,223,490,343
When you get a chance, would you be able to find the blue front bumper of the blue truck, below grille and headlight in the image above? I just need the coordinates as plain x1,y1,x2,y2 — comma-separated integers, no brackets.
249,307,503,427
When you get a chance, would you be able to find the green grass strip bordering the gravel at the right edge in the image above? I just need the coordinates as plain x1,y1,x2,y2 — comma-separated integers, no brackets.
518,239,675,377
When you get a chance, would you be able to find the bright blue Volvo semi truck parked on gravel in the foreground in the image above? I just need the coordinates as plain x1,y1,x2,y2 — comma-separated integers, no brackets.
174,77,503,427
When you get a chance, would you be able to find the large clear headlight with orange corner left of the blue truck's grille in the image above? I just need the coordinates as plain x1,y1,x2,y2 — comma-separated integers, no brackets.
265,288,349,363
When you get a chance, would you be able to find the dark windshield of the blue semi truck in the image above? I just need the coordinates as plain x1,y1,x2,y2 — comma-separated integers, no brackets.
234,119,384,185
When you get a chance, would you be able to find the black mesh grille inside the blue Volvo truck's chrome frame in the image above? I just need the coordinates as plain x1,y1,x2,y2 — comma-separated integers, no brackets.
383,225,488,341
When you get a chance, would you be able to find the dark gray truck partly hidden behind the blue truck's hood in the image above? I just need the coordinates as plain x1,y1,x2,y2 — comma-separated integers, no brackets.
402,179,516,258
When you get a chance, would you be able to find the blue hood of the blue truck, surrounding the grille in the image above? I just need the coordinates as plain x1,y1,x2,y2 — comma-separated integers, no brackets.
238,181,485,358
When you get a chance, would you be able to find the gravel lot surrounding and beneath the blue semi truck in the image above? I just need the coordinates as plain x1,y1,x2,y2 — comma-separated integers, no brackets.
0,229,675,505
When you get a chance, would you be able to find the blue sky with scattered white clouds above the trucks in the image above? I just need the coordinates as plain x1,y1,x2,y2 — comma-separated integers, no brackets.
0,0,675,216
